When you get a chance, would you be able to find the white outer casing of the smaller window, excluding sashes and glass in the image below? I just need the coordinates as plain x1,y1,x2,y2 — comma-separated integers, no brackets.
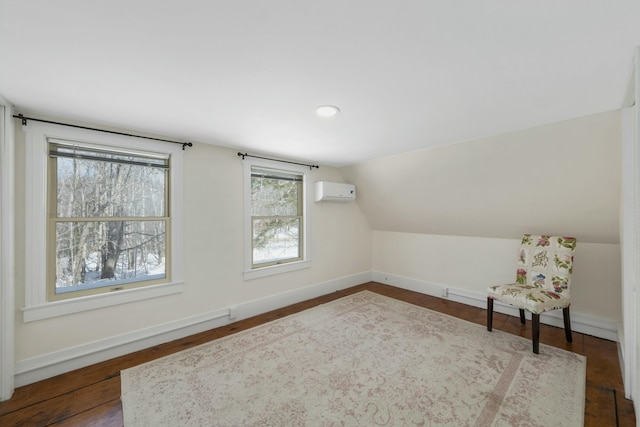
243,158,311,280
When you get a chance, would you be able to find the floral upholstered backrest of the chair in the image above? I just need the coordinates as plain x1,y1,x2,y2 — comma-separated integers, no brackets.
516,234,576,297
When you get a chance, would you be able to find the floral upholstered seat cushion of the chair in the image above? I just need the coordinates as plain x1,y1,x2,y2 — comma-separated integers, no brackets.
487,283,570,314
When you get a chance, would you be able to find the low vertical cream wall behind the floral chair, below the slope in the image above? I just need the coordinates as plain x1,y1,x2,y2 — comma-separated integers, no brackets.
373,231,621,325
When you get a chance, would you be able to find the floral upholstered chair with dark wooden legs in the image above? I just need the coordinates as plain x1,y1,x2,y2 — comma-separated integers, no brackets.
487,234,576,354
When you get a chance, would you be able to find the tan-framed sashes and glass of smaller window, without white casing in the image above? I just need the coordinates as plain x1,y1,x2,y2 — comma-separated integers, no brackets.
251,166,304,269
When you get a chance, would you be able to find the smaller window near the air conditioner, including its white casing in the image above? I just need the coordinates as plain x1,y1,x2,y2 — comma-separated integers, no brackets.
245,160,309,279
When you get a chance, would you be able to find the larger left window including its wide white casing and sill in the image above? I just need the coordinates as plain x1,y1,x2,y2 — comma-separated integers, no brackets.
22,122,183,322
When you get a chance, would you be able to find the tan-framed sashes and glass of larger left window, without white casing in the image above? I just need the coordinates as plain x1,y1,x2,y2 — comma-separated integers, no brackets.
47,140,170,300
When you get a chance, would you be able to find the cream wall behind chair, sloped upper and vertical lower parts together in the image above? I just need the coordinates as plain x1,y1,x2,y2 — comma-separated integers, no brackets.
341,111,622,339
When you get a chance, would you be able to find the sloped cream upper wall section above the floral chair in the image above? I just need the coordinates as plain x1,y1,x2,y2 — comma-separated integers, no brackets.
341,112,622,244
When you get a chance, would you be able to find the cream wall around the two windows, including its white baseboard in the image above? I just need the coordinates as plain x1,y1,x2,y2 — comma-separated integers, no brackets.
15,125,371,385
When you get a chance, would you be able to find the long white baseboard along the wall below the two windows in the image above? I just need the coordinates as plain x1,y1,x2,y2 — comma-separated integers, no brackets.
15,271,371,387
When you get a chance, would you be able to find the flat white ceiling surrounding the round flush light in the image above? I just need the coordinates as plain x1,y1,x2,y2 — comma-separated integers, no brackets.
0,0,640,166
